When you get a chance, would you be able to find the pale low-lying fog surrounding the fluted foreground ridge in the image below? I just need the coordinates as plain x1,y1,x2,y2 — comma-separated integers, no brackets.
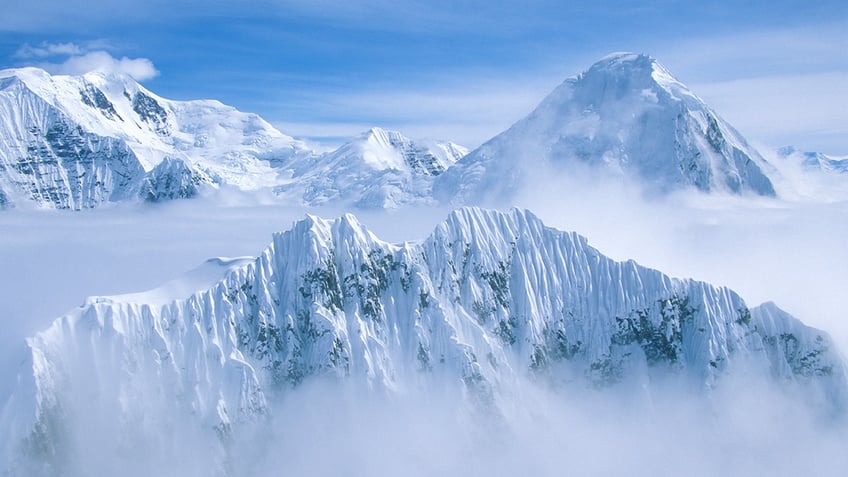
0,165,848,475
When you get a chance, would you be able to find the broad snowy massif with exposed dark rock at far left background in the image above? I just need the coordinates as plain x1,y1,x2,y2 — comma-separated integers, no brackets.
0,68,310,209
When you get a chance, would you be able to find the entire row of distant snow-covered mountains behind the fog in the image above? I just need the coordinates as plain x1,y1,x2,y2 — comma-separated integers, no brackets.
0,53,848,209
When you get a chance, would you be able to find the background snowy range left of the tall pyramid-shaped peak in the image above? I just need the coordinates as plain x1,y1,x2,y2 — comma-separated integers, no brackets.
0,68,467,210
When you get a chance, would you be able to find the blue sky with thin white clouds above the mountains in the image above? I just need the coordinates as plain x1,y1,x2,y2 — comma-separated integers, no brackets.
0,0,848,154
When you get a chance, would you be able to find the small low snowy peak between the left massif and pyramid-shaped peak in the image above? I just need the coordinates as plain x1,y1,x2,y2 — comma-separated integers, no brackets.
276,128,468,208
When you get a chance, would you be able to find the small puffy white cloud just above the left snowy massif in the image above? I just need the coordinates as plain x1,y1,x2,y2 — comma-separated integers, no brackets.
14,42,159,81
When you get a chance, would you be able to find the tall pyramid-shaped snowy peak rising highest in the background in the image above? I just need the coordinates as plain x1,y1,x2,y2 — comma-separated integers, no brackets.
436,53,775,203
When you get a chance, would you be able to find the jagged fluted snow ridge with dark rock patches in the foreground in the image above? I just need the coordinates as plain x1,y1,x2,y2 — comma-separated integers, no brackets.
0,209,848,475
